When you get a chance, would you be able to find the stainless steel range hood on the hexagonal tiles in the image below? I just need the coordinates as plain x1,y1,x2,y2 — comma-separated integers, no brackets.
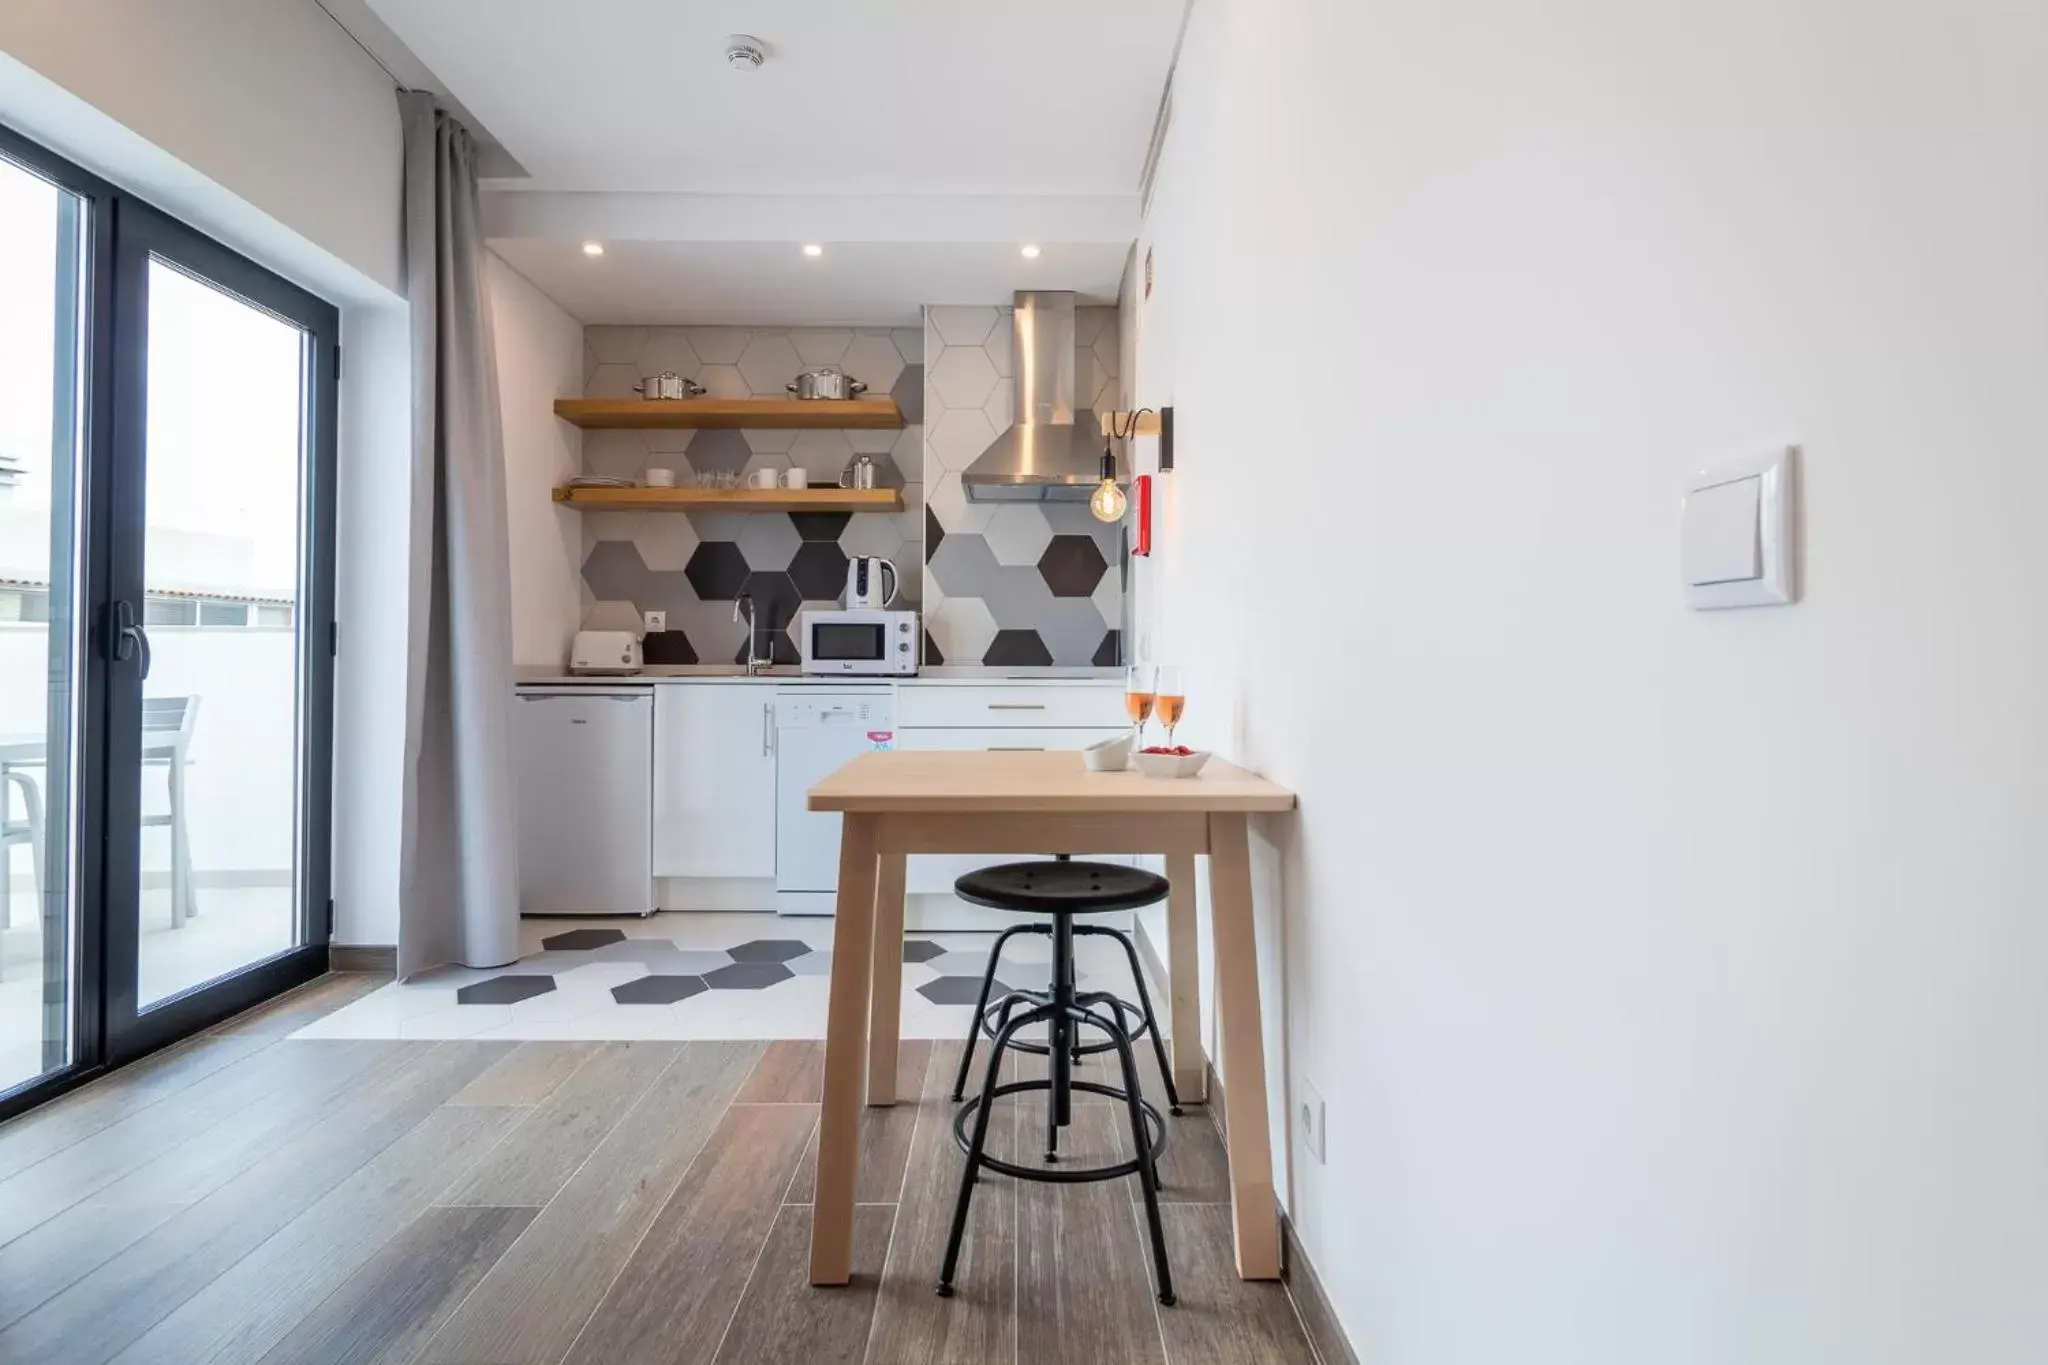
961,293,1102,501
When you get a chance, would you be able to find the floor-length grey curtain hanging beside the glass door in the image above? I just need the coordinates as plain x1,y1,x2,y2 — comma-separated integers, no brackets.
397,92,518,976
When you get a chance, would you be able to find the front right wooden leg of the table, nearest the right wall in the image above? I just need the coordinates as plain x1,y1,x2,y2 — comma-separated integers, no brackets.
1208,814,1280,1279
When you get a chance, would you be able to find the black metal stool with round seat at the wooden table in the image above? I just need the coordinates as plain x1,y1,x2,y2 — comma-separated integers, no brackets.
938,857,1178,1304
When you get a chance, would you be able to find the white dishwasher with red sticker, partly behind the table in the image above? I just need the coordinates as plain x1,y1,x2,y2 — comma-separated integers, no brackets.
774,686,895,915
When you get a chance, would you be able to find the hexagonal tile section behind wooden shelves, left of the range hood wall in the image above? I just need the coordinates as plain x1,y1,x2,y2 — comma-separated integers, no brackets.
584,327,924,663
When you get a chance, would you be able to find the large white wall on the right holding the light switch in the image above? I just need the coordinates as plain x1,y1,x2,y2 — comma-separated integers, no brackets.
1137,0,2048,1365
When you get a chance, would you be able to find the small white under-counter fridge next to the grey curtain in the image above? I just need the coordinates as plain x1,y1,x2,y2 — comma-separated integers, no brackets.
512,686,655,915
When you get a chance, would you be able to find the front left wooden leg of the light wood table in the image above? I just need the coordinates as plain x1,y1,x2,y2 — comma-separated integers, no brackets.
811,814,877,1285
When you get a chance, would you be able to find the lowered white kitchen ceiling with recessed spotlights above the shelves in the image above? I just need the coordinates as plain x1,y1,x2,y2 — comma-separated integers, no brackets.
492,237,1128,327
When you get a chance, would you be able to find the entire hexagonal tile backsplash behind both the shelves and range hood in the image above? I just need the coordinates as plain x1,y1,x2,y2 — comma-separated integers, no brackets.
584,307,1126,667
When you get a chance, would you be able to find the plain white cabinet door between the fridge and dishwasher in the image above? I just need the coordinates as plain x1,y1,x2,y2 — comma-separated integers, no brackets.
653,681,774,878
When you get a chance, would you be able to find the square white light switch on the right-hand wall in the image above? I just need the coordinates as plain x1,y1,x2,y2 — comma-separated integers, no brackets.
1679,446,1796,610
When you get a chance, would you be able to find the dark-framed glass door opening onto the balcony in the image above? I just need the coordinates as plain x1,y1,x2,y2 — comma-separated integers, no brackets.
0,122,338,1115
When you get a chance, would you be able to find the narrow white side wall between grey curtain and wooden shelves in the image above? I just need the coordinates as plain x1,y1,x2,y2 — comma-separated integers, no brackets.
483,252,584,667
